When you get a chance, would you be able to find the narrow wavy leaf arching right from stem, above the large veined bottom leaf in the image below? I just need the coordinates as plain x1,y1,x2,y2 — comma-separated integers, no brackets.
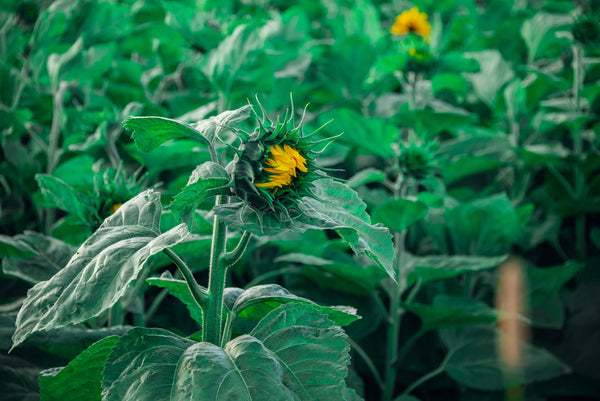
232,284,360,326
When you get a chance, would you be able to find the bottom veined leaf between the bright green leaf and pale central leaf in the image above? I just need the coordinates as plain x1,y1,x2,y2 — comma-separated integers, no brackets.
102,328,194,401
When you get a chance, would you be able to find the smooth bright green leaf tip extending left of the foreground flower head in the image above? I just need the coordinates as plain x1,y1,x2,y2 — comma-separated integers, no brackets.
123,116,210,152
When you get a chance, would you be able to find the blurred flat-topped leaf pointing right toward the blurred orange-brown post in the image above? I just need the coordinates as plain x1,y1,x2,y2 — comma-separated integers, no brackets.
404,255,507,285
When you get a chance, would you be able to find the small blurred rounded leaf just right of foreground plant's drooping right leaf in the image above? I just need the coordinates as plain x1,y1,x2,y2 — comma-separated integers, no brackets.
372,199,428,233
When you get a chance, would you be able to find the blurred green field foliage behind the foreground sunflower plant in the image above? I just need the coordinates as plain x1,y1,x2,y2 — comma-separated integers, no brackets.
0,0,600,401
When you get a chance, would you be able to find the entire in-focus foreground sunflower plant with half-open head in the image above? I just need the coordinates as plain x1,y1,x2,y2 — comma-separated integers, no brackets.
13,105,395,400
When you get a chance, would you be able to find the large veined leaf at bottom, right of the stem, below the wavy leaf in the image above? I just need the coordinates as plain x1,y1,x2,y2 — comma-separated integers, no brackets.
250,304,350,401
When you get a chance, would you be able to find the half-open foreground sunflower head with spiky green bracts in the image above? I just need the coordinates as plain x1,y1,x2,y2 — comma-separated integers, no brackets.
228,103,321,216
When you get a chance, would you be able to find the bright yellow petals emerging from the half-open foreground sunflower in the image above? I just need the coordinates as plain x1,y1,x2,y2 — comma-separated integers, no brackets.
254,144,308,190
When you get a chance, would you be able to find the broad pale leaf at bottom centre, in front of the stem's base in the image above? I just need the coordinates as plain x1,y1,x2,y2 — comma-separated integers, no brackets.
171,335,295,401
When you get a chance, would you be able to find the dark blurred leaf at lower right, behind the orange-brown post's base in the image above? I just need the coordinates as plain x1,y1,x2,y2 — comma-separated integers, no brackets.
441,327,570,390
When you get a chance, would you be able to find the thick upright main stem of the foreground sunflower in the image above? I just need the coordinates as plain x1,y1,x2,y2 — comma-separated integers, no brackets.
202,196,227,345
